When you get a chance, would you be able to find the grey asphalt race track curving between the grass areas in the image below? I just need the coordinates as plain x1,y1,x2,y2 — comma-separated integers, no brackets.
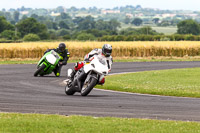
0,62,200,121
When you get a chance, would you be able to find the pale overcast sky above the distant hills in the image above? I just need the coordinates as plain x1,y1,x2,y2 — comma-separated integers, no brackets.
0,0,200,11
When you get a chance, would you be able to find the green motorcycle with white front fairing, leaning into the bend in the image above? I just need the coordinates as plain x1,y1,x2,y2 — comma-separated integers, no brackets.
34,50,61,77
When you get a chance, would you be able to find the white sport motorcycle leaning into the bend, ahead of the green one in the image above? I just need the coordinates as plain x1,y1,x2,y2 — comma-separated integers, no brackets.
65,55,109,96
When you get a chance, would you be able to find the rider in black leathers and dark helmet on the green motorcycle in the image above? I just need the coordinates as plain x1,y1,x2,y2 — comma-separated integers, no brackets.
44,43,70,77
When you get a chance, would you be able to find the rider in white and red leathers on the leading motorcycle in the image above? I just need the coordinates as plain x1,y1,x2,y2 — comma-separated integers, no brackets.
69,44,113,84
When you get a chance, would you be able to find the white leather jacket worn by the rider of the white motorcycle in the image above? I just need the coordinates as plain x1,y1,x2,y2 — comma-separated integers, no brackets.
84,49,113,71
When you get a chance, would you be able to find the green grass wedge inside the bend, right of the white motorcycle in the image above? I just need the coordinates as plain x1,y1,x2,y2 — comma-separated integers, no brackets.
97,68,200,98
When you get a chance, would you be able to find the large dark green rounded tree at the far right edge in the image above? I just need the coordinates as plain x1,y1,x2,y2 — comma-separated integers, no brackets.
177,20,200,35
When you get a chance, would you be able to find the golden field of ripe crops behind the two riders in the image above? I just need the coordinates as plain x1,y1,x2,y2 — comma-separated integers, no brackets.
0,41,200,59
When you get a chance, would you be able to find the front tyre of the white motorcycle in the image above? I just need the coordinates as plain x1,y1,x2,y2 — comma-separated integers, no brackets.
81,77,97,96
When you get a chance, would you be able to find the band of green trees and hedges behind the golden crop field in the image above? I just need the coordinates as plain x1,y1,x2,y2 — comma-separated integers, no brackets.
0,13,200,42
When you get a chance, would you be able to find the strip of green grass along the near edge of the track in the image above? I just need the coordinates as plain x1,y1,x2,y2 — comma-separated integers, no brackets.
0,113,200,133
